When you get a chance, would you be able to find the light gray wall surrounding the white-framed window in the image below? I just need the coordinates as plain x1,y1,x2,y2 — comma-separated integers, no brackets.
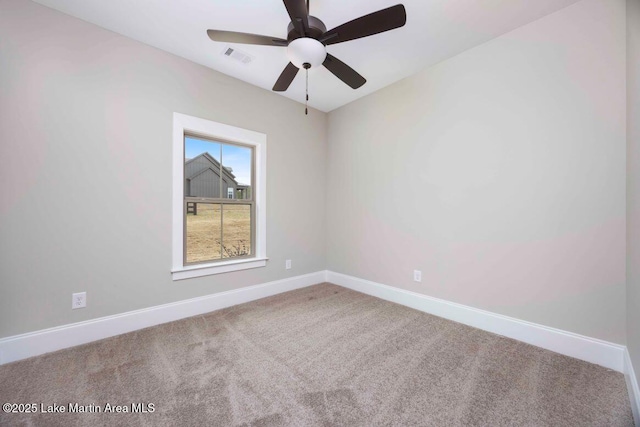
0,0,326,337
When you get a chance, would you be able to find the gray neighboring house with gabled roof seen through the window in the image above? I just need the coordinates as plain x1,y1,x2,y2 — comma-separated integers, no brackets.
184,153,250,199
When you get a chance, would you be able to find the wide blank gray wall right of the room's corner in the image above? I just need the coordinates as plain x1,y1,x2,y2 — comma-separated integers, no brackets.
326,0,626,343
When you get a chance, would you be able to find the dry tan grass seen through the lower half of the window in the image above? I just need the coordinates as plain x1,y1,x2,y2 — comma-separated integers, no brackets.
187,203,251,262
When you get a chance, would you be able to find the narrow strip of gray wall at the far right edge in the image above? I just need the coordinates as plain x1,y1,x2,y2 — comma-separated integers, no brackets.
627,0,640,383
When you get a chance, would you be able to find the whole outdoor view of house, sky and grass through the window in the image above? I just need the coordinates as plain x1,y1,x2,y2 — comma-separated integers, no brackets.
184,135,255,264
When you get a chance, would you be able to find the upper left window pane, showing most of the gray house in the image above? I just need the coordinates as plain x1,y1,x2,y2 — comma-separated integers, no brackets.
184,136,222,198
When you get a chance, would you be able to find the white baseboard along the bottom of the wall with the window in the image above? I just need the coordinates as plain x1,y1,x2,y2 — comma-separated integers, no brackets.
0,271,326,365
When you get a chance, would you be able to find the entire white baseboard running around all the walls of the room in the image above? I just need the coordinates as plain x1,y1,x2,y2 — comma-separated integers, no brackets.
0,271,640,382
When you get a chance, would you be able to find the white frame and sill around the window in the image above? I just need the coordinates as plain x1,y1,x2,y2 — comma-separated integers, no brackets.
171,113,269,280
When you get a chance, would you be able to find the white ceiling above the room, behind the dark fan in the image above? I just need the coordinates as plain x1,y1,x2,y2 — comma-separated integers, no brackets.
35,0,578,112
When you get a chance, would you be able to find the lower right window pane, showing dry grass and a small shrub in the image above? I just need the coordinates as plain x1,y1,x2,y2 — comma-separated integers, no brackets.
222,205,251,258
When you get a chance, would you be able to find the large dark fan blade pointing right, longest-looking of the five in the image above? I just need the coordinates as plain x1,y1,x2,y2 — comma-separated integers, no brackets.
320,4,407,45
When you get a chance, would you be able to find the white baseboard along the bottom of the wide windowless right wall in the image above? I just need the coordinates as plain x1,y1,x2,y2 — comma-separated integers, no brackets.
327,271,626,372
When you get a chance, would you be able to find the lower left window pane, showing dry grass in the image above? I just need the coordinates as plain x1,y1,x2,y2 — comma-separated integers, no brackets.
186,202,222,263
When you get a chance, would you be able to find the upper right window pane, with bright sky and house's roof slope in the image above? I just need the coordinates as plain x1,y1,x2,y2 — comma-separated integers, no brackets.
222,144,253,200
